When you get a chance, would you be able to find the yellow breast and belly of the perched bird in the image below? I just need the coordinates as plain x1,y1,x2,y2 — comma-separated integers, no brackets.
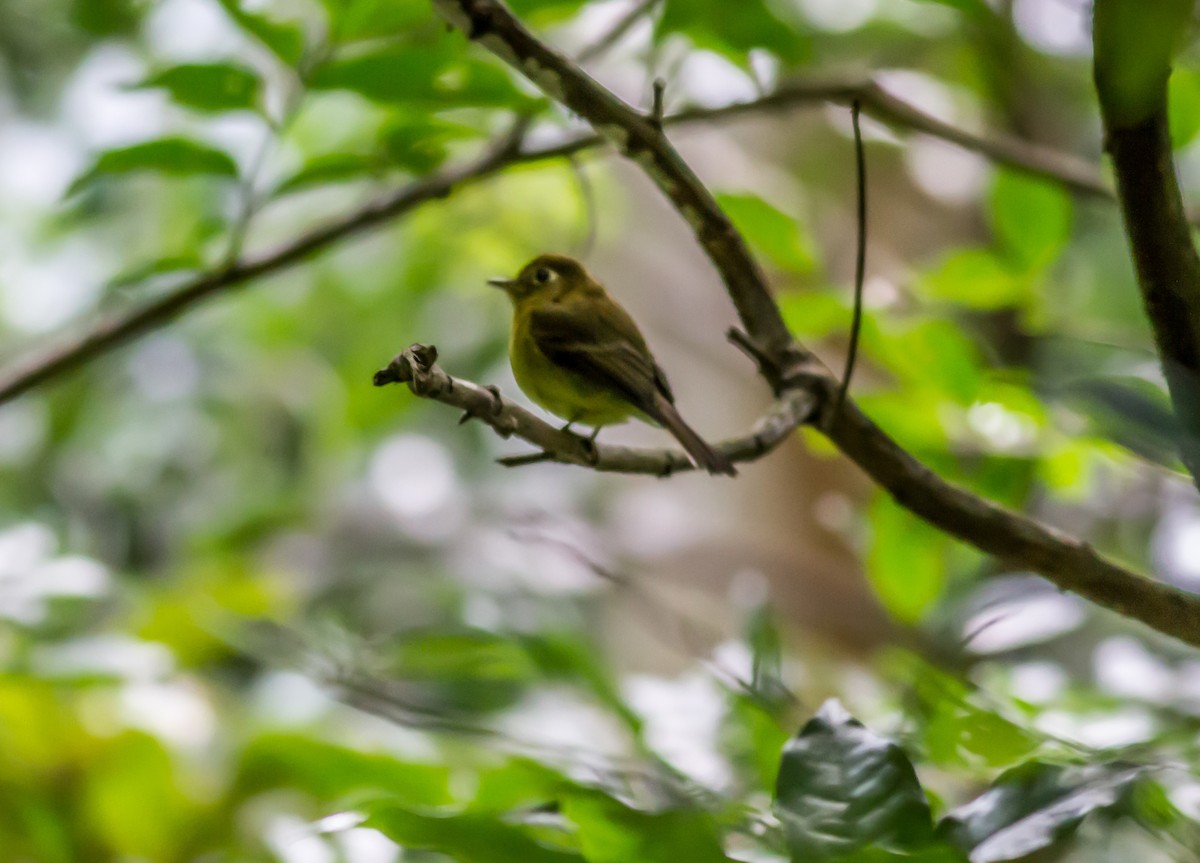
509,307,636,426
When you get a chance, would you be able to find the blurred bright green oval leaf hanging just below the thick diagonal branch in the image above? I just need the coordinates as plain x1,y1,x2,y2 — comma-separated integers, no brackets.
866,495,949,623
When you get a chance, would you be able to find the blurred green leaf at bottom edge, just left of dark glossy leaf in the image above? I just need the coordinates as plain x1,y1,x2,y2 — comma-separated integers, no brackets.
562,790,728,863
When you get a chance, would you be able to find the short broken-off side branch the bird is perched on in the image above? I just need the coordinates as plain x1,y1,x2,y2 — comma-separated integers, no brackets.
374,344,816,477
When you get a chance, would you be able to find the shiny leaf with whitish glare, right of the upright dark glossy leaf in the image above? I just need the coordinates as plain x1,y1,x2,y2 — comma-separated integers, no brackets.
937,761,1144,863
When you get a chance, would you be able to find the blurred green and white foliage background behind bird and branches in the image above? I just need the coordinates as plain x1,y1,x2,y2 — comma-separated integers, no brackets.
0,0,1200,863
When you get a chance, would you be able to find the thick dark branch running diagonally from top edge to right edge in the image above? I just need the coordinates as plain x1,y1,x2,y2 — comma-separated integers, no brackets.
433,0,1200,647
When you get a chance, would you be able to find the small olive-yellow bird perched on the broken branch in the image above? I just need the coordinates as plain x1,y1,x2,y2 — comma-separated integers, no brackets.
487,254,737,477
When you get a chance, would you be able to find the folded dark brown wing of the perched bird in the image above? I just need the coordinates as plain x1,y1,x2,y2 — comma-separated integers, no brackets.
529,304,674,416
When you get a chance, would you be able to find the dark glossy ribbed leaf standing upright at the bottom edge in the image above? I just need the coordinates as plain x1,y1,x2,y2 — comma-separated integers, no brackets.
775,700,934,863
